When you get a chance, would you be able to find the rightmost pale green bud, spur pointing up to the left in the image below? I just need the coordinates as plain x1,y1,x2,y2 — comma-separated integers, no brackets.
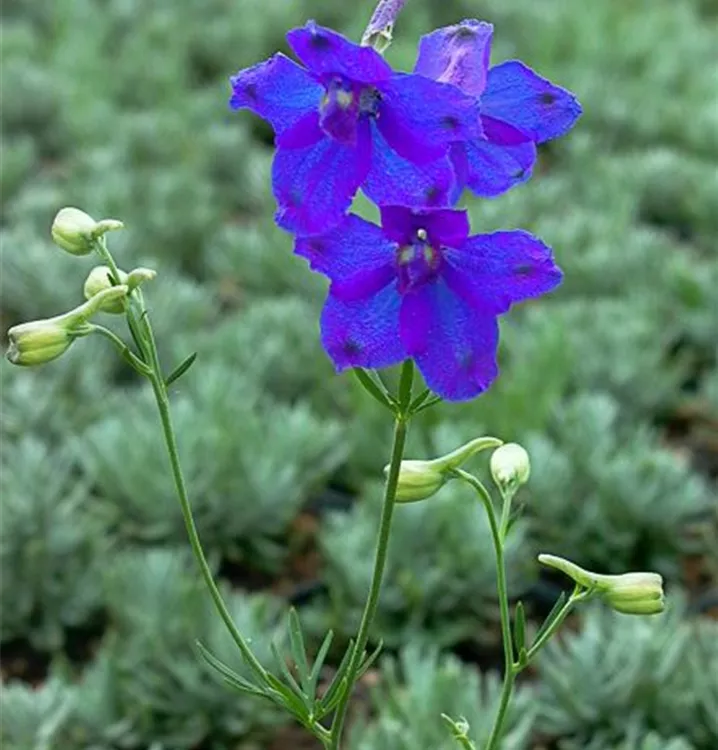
538,555,665,615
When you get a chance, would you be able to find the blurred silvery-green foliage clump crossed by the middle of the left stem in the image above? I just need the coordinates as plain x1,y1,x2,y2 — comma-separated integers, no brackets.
76,364,346,568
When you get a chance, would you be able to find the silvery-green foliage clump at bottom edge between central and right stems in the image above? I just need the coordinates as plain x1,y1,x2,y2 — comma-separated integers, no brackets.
349,643,536,750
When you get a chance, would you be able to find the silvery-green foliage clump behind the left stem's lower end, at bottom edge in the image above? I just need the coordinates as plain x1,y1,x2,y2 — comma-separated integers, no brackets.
99,549,286,750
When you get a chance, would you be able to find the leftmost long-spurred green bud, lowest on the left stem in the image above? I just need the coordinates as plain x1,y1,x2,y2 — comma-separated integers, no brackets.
7,286,127,367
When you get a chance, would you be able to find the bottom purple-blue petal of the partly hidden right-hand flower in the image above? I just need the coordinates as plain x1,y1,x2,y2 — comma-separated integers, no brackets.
451,139,536,198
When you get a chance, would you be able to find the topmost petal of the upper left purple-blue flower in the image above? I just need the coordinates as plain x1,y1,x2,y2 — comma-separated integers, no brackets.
287,21,391,83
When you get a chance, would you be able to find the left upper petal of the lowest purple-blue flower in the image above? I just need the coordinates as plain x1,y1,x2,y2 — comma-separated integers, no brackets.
294,214,396,299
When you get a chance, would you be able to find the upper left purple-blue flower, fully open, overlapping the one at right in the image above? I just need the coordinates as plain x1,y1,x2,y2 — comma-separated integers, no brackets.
230,21,481,234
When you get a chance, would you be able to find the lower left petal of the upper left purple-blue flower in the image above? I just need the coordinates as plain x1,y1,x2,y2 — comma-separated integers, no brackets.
272,121,371,235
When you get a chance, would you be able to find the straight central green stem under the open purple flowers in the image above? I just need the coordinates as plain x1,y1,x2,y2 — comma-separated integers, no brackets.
329,360,414,750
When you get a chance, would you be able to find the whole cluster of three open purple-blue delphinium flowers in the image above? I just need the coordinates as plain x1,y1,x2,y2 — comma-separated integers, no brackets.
230,20,581,400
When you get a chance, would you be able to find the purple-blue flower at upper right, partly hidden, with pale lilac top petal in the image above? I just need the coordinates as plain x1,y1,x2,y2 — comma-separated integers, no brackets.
414,20,581,198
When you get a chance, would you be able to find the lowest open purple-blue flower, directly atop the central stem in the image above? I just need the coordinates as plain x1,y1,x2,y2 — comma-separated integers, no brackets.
295,206,561,401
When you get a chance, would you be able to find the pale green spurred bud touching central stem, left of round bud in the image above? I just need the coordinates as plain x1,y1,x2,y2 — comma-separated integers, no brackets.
384,437,501,503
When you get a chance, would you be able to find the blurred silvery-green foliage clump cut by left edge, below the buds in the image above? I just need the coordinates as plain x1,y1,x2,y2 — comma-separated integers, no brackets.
0,437,107,650
